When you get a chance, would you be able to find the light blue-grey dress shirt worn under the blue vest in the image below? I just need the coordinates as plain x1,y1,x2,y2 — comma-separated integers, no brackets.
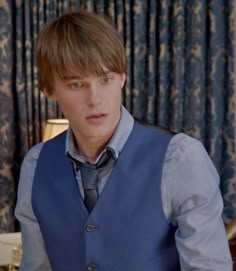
15,106,232,271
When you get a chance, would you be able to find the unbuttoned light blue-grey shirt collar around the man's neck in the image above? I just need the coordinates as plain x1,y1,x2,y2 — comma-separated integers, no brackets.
65,105,134,163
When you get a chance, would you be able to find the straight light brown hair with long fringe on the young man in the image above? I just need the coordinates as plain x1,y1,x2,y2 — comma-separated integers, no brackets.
36,11,126,95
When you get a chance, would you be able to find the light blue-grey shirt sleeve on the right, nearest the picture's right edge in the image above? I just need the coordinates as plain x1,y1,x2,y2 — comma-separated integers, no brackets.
162,134,232,271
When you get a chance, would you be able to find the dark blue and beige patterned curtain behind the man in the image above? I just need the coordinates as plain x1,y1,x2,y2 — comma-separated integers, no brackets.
0,0,236,232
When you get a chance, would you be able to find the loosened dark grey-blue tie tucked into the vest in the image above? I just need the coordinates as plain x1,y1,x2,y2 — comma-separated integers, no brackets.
79,151,115,213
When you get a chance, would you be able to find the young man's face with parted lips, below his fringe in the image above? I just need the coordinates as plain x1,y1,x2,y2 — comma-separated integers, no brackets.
52,72,126,146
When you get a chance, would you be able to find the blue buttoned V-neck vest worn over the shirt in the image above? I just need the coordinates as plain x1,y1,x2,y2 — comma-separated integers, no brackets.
32,123,180,271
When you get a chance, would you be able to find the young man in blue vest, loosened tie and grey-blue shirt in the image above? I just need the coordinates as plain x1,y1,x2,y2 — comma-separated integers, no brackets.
16,12,232,271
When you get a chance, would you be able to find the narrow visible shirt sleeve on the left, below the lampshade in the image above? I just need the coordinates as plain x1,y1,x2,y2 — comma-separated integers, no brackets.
15,143,52,271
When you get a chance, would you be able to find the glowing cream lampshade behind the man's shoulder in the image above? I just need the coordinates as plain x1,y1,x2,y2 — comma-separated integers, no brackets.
43,119,69,141
